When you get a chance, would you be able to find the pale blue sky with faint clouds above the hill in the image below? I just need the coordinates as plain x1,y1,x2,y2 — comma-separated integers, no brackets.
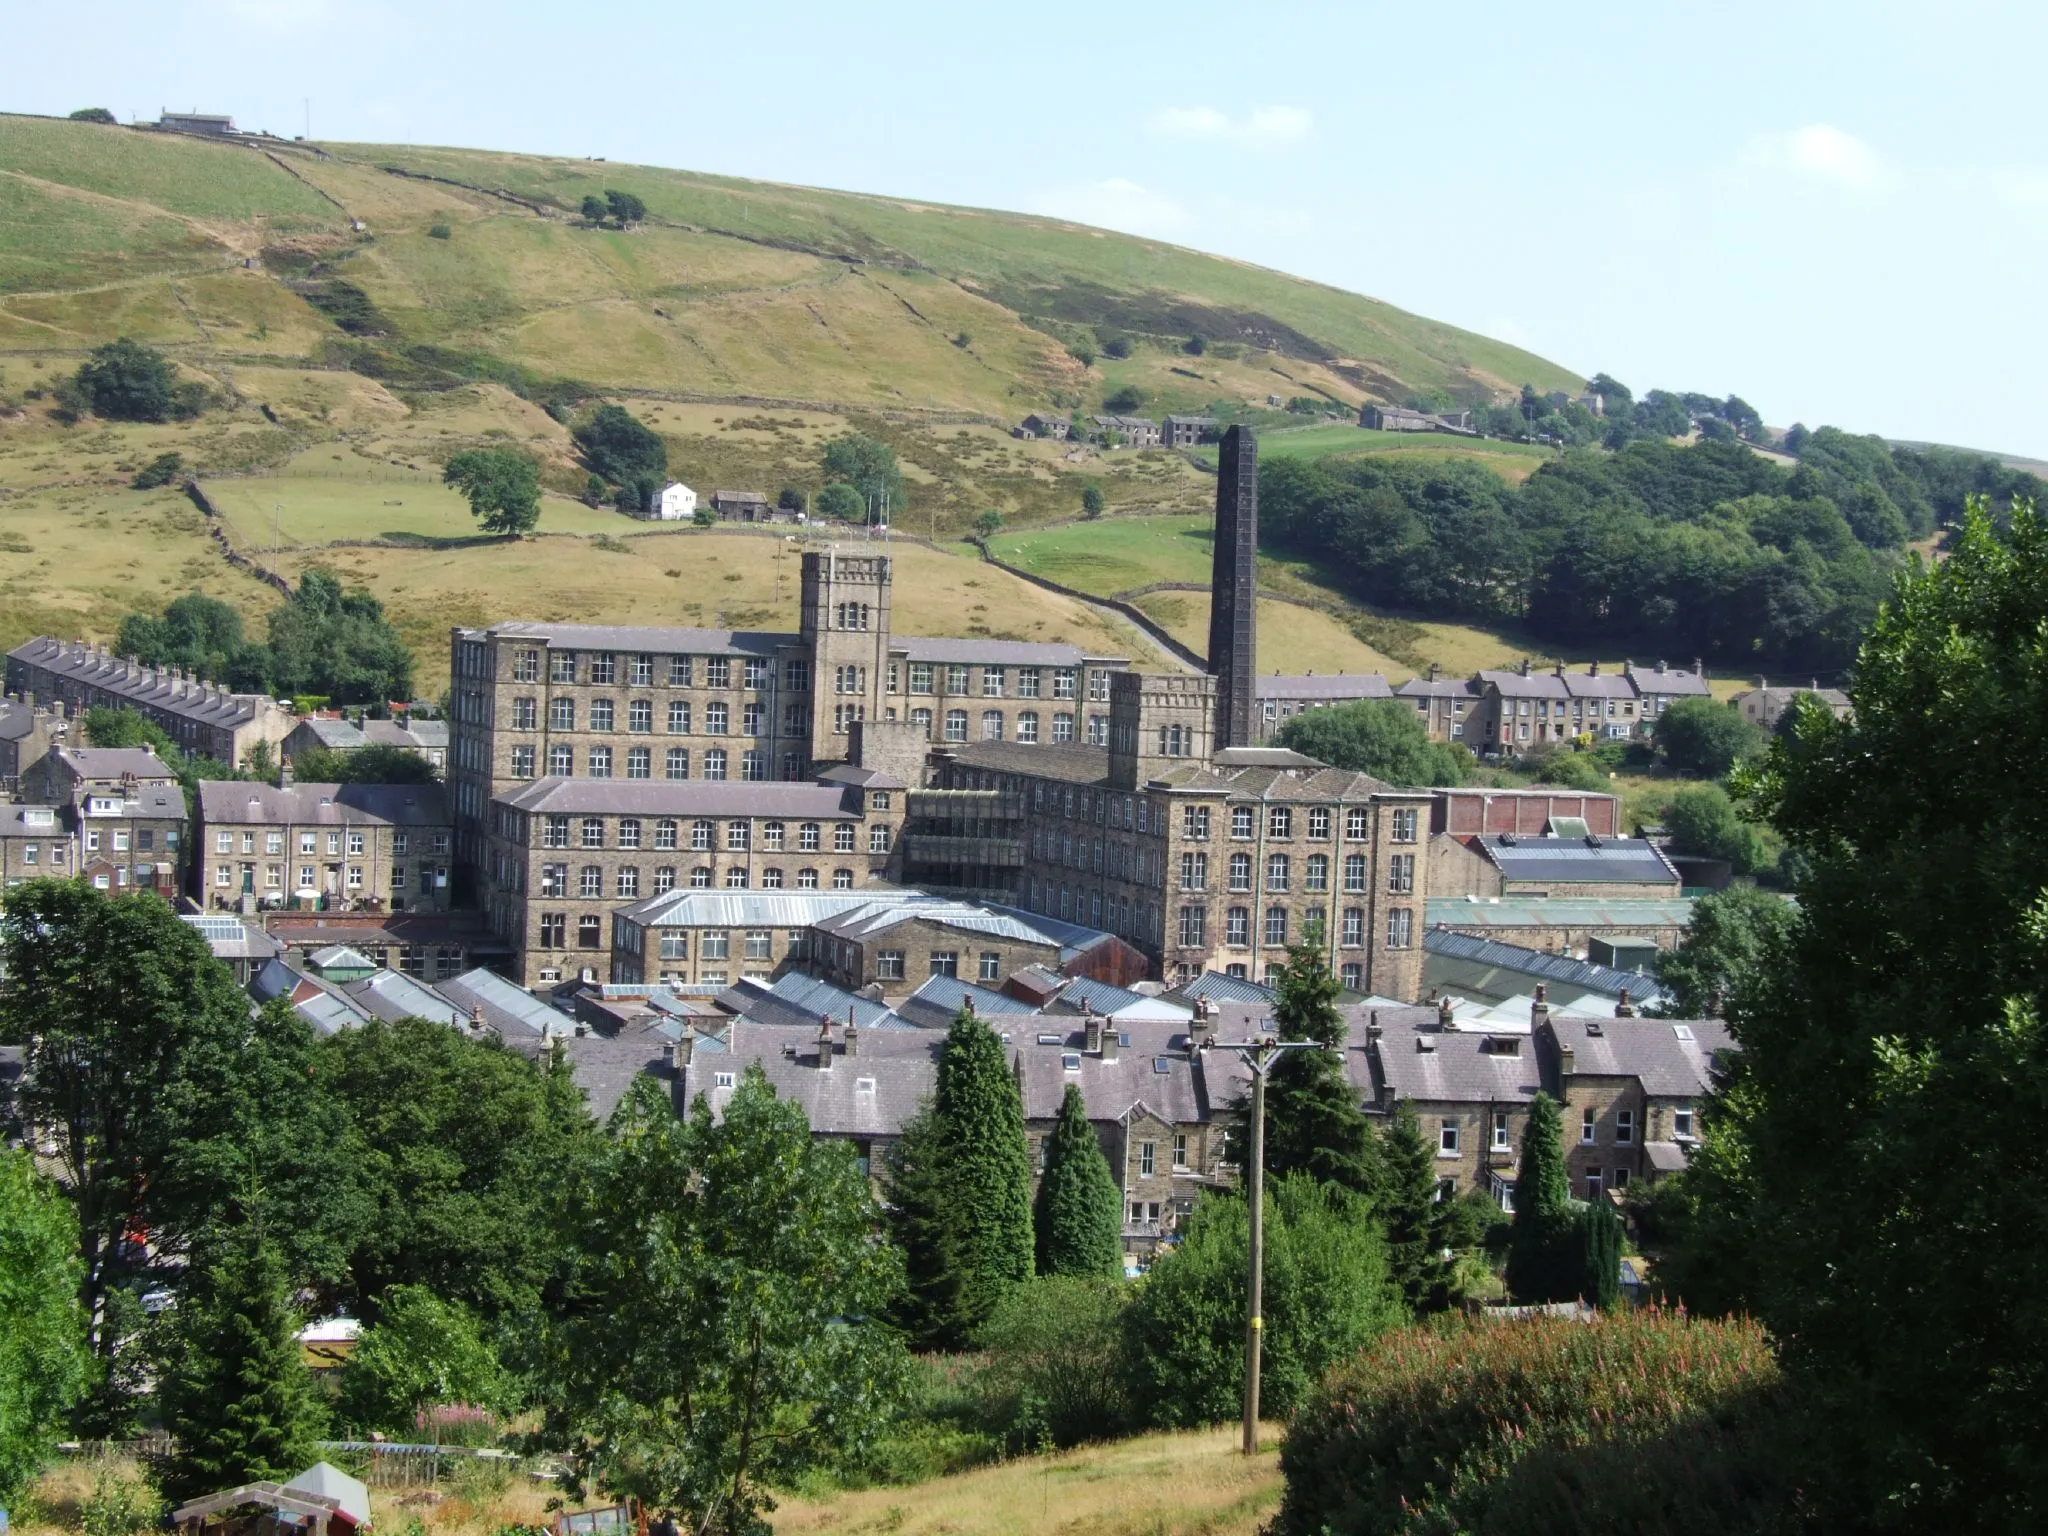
0,0,2048,459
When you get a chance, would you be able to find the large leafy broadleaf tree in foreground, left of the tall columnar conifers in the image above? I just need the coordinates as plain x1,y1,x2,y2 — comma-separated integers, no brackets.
545,1067,905,1536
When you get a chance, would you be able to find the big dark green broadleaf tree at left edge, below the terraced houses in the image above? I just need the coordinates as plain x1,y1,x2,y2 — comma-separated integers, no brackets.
0,881,362,1360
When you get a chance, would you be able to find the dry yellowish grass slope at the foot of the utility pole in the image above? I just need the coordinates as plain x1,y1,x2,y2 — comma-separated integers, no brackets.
774,1427,1280,1536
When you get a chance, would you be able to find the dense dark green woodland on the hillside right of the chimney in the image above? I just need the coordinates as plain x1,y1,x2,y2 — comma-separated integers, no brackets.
1260,428,2040,674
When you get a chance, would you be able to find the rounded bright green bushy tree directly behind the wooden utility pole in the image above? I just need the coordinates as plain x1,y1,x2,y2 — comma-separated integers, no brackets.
1122,1176,1405,1430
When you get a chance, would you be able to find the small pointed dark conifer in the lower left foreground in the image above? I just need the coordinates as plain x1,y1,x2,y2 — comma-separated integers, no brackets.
158,1217,324,1499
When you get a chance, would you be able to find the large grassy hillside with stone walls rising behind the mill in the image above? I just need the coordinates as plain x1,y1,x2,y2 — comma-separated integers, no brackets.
0,115,1577,682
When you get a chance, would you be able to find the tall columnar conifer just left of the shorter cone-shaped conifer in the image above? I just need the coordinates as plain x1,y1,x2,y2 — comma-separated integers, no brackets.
932,1008,1032,1329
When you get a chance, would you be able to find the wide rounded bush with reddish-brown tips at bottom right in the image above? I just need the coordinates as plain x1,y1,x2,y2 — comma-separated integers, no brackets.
1272,1311,1778,1536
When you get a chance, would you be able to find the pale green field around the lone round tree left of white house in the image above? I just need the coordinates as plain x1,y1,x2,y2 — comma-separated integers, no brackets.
205,471,630,551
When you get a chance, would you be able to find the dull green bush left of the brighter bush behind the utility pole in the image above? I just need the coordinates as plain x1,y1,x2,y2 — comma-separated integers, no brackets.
977,1276,1133,1454
